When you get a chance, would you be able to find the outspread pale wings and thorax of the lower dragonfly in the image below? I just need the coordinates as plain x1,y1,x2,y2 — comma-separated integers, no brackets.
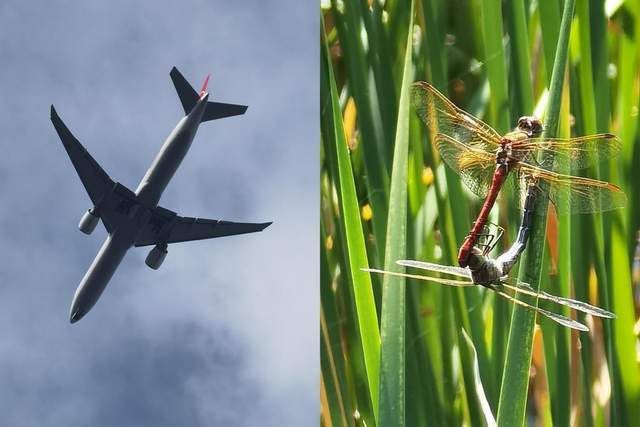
362,246,616,332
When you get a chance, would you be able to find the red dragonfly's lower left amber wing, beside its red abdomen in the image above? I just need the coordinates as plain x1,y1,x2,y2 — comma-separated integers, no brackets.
434,134,496,198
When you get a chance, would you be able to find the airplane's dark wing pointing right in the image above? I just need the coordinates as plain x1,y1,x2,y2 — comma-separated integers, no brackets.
135,206,271,246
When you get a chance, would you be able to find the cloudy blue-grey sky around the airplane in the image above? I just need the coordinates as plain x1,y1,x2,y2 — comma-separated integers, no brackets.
0,0,319,426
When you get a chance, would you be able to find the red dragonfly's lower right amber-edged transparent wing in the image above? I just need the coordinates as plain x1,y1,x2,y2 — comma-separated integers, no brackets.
518,163,627,213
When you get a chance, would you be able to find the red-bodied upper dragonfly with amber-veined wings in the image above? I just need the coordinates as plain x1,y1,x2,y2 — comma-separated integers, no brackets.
412,82,626,267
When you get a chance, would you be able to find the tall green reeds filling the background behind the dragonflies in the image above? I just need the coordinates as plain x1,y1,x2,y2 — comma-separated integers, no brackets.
320,0,640,426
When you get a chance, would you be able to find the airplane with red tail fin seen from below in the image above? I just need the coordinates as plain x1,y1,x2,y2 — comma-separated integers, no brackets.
51,67,271,323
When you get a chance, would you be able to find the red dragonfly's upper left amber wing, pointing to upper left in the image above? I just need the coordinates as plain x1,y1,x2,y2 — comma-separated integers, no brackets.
411,82,500,151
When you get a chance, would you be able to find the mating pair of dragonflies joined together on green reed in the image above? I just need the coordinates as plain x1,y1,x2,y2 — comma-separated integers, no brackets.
364,82,626,331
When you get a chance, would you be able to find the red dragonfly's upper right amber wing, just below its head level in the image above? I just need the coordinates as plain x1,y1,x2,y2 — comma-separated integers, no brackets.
512,133,622,171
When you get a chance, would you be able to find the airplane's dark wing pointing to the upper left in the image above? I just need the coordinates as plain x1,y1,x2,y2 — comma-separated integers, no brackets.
51,105,136,232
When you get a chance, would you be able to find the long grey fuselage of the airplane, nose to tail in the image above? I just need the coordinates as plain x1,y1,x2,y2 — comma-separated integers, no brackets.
70,93,208,323
